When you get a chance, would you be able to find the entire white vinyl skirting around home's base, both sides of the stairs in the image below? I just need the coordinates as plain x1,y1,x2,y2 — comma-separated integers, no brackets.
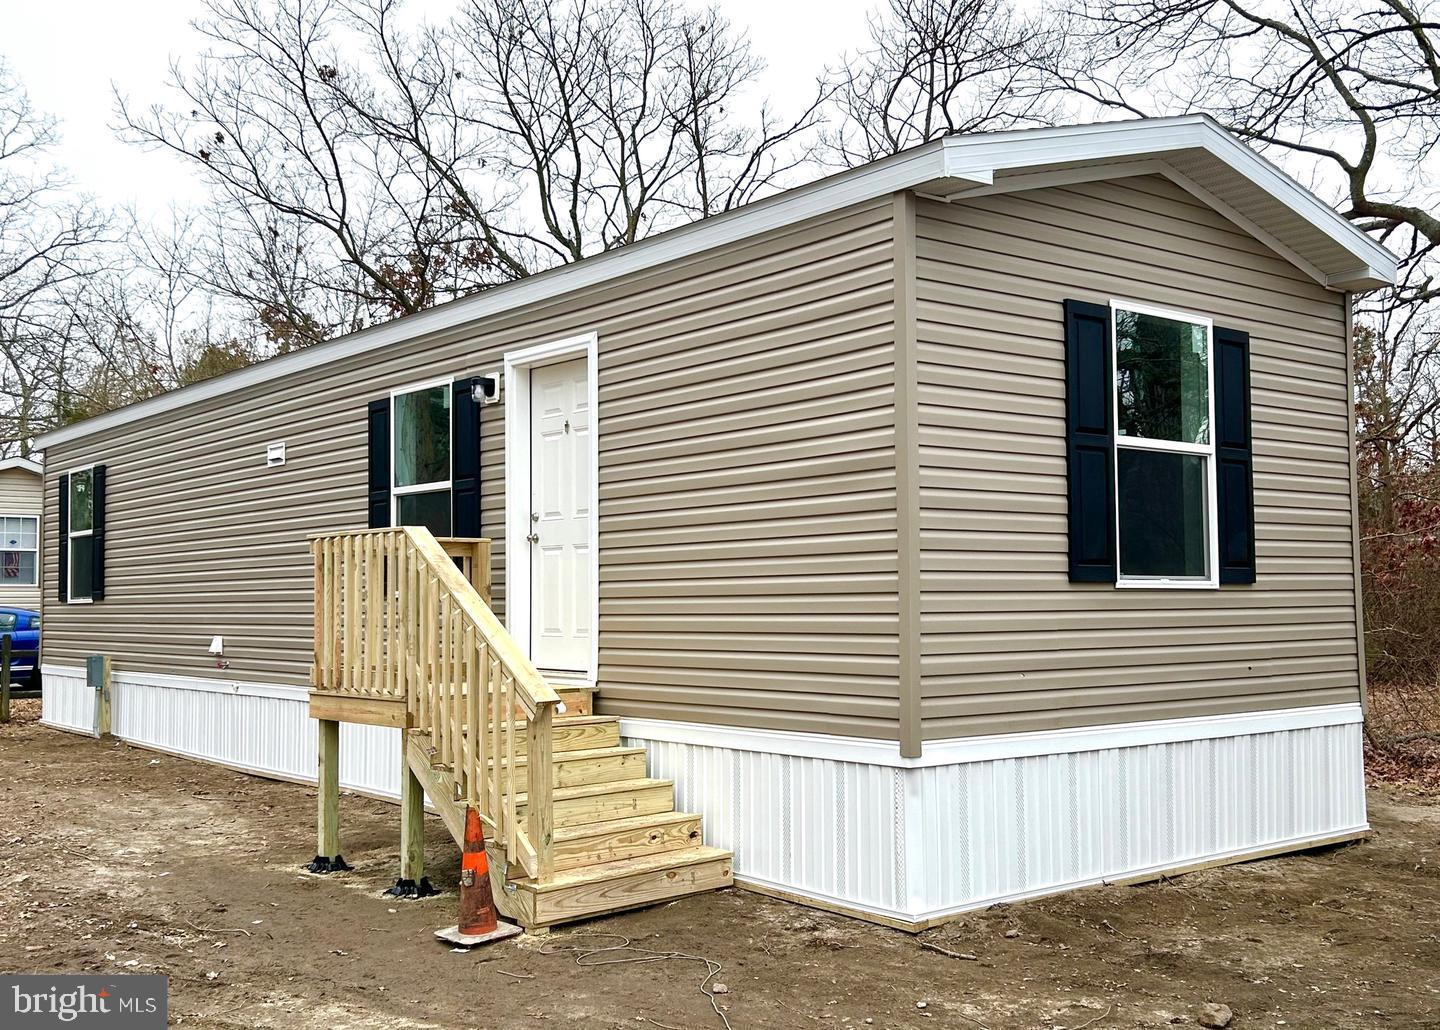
43,666,1367,922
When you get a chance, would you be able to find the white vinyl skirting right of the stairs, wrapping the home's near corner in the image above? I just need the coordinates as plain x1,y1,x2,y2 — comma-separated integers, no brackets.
622,704,1367,923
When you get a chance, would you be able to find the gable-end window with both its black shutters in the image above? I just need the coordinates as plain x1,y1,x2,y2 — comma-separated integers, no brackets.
1066,301,1254,588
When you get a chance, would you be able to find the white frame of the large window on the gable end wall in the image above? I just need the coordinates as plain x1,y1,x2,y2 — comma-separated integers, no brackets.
1110,298,1220,591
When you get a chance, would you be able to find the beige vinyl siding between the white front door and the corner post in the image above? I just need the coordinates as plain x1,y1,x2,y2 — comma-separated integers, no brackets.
599,203,899,738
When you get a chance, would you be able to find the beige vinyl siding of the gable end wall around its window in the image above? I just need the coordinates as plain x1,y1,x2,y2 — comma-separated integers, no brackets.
916,176,1359,739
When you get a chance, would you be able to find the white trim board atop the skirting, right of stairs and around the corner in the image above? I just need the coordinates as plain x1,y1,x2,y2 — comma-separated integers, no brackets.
621,703,1365,769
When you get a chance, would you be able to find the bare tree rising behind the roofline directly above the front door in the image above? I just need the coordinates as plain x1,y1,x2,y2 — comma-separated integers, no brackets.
458,0,825,253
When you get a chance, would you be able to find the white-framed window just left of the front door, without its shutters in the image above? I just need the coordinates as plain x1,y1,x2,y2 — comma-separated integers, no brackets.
390,382,451,536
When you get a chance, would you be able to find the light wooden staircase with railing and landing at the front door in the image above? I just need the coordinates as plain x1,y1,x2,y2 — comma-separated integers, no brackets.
311,527,732,928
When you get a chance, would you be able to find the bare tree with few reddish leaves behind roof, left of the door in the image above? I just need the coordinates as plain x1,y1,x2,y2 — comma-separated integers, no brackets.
118,0,472,339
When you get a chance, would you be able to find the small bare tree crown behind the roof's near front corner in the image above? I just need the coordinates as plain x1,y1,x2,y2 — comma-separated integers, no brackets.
827,0,1058,164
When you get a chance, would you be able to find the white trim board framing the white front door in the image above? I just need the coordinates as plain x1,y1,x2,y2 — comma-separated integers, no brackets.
504,333,600,683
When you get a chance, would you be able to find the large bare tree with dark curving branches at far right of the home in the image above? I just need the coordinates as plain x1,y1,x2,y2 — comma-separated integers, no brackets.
1013,0,1440,700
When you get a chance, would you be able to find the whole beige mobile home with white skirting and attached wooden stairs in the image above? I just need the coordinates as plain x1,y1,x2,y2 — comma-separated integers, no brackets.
39,115,1395,928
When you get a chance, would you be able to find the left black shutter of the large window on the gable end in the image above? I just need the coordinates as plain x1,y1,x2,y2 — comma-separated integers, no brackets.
1066,301,1115,583
